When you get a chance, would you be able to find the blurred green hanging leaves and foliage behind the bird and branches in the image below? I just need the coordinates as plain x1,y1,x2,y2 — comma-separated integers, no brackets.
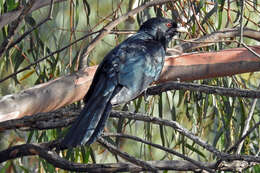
0,0,260,172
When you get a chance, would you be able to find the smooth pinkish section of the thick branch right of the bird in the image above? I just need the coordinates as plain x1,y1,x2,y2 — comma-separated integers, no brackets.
157,44,260,83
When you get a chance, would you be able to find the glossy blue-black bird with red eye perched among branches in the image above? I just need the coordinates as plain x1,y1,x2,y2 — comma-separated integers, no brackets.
61,18,183,148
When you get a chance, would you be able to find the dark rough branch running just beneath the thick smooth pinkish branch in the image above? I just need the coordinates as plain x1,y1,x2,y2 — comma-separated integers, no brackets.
0,79,260,131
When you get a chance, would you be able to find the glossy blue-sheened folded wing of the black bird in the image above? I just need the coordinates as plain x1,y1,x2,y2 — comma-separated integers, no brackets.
111,39,165,104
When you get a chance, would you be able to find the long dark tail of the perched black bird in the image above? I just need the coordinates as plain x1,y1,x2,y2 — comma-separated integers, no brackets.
61,81,116,148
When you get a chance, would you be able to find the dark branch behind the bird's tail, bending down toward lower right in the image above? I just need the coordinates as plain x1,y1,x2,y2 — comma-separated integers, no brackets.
0,110,221,157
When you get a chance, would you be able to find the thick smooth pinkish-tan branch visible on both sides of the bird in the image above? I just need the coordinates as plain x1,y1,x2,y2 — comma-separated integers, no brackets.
0,47,260,121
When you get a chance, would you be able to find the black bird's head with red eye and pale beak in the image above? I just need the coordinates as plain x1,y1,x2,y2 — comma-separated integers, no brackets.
139,17,184,47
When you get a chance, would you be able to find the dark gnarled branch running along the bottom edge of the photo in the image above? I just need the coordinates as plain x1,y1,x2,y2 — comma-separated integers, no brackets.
0,134,260,172
